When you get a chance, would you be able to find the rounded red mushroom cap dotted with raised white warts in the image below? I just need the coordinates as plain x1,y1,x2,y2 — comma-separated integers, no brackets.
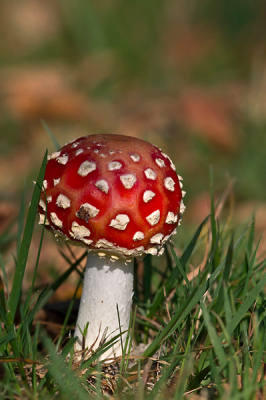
39,135,185,259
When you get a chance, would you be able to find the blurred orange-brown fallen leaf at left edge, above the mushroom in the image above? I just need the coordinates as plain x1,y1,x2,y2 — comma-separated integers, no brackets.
0,65,91,121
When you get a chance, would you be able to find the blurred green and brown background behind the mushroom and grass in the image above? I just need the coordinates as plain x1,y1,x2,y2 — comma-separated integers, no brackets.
0,0,266,278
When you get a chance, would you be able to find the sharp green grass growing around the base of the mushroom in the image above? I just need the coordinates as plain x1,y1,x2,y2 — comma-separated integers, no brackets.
0,155,266,400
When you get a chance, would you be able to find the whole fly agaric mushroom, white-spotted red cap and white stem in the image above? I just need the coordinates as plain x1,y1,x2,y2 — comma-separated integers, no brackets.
39,135,185,357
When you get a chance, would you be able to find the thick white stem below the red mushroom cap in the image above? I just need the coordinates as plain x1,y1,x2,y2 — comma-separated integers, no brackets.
75,253,134,360
